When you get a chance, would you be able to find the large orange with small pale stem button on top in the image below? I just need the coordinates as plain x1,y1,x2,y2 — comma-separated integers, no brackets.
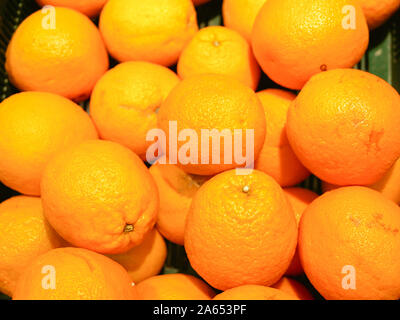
185,170,297,290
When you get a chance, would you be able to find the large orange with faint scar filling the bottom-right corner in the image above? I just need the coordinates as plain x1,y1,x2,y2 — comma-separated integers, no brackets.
299,186,400,300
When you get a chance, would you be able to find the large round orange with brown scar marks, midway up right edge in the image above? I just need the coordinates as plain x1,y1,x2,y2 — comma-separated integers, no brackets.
287,69,400,185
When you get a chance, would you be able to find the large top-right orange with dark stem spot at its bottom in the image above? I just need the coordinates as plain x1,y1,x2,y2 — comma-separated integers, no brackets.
251,0,369,89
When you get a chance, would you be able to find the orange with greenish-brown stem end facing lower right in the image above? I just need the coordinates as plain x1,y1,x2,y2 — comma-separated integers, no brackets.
41,140,159,254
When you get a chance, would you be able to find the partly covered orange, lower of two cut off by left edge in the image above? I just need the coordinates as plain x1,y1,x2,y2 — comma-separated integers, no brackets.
0,196,61,296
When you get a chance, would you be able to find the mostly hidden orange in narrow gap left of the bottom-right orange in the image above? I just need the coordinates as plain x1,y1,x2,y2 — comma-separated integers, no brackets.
283,188,318,276
